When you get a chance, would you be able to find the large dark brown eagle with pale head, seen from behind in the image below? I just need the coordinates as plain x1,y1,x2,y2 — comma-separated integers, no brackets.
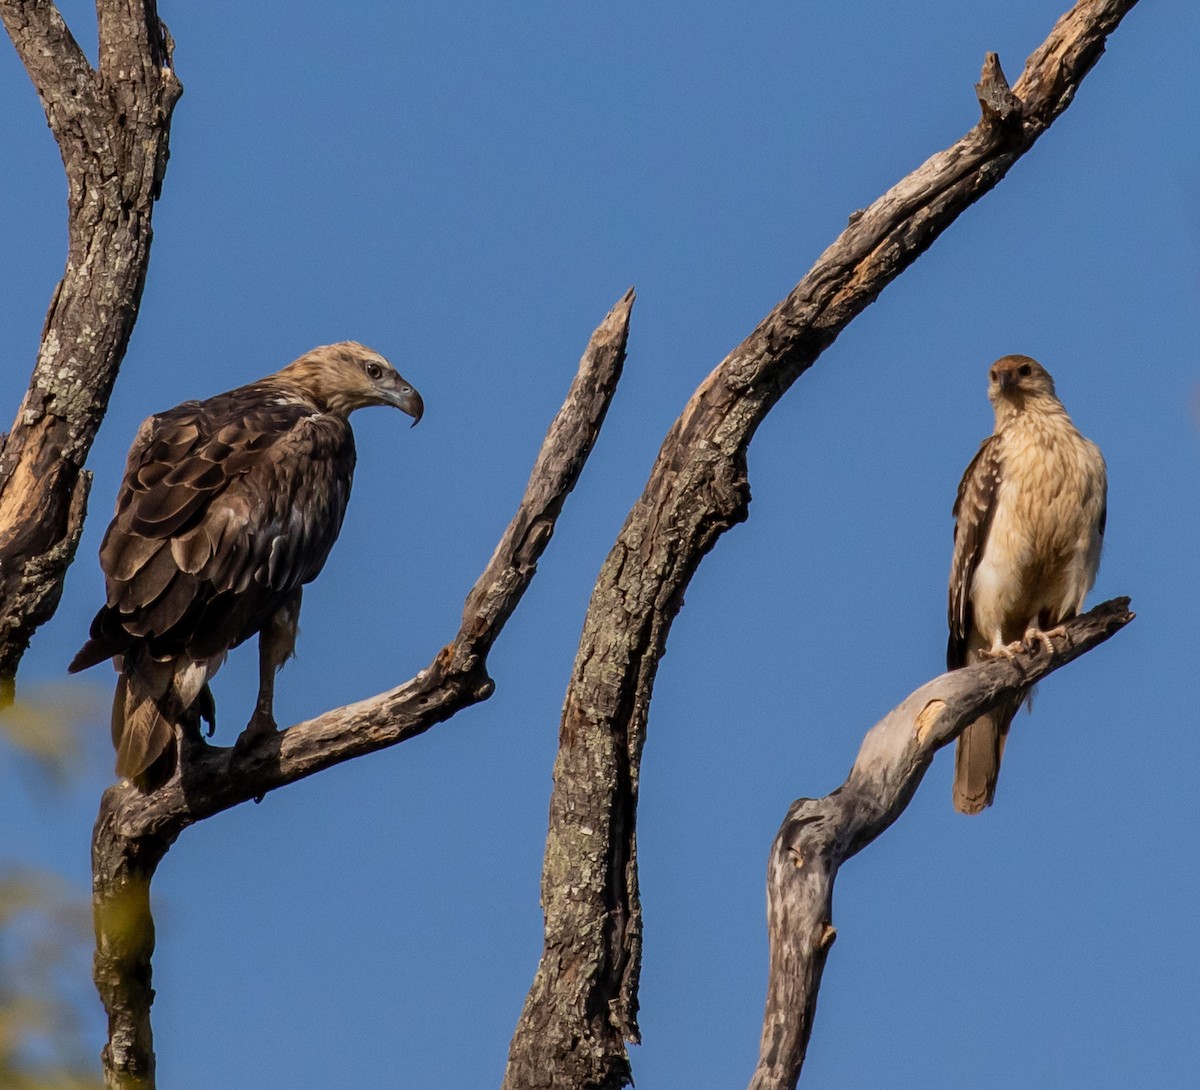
70,341,424,790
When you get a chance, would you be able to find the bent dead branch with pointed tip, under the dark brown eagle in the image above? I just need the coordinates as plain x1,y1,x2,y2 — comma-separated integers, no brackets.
92,291,634,1090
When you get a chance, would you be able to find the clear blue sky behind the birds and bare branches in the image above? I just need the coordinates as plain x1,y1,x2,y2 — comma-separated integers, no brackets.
0,0,1200,1090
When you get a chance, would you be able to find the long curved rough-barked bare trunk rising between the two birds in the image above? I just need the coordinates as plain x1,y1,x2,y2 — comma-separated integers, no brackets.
504,0,1135,1090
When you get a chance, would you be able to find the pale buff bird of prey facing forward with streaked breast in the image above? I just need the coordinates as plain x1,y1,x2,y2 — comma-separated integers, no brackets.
946,355,1108,814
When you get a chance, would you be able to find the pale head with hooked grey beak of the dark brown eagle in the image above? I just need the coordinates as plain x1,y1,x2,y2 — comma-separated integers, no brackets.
280,341,425,427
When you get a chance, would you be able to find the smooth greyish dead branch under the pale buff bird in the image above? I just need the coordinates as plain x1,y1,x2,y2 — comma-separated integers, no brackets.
750,598,1133,1090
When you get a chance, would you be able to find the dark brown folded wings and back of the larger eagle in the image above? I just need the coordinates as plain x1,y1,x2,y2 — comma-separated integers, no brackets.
71,387,354,670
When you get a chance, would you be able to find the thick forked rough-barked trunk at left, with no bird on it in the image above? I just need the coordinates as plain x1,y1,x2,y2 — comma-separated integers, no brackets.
0,0,182,706
